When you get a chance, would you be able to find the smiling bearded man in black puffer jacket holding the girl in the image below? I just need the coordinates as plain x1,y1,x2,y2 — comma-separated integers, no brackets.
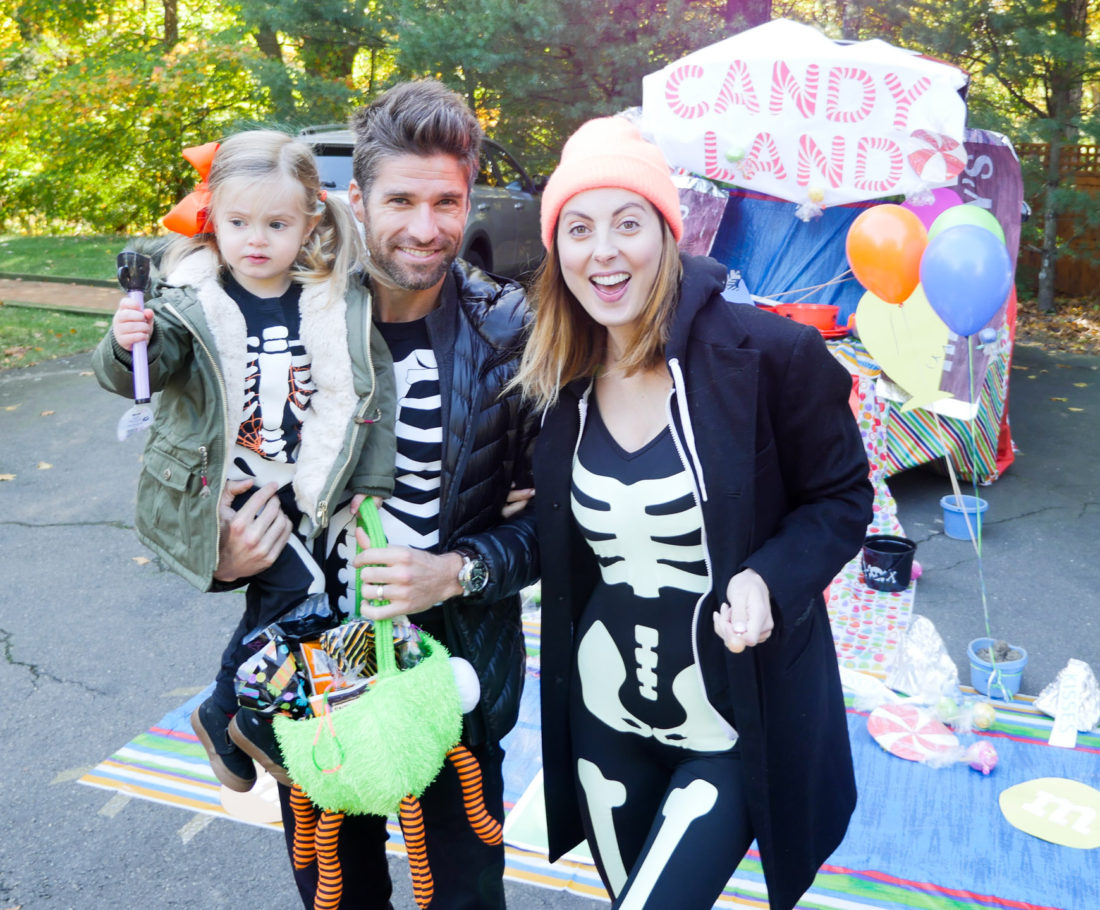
229,81,538,910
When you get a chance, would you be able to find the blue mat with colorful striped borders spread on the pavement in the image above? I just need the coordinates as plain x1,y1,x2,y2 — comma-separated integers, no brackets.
80,601,1100,910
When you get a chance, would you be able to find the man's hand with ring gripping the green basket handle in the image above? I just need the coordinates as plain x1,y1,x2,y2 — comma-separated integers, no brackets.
352,528,462,620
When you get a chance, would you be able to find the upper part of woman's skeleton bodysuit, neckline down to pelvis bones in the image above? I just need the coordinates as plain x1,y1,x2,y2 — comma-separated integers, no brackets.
571,395,736,752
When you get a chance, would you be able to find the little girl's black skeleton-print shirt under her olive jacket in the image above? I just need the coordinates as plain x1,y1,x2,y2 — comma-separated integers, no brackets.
224,273,315,495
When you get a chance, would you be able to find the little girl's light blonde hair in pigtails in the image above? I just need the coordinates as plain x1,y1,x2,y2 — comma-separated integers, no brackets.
164,130,362,303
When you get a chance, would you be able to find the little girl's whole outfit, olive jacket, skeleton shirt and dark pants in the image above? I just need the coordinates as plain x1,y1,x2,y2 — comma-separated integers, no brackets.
94,250,396,713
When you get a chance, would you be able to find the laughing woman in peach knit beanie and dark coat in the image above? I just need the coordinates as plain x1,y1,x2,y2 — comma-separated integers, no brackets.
517,118,872,910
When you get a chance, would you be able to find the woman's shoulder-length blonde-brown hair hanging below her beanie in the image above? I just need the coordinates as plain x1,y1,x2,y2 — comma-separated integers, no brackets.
509,218,682,409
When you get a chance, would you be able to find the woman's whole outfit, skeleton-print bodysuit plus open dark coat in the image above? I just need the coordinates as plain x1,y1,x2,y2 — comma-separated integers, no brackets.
535,257,872,910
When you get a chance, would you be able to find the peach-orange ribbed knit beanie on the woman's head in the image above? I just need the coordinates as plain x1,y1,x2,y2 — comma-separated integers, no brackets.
542,117,683,250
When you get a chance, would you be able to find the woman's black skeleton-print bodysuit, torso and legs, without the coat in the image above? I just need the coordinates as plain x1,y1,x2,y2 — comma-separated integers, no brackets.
570,395,751,910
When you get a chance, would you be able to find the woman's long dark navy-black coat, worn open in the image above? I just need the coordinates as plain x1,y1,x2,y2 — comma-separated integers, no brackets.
535,257,872,910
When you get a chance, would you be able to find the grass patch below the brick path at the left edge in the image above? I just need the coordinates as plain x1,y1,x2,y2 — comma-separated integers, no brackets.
0,304,111,370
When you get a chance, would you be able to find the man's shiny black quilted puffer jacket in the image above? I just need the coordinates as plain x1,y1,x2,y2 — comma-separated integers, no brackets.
413,262,539,744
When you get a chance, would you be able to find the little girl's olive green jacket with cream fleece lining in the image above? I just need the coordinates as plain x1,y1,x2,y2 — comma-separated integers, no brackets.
92,250,396,591
